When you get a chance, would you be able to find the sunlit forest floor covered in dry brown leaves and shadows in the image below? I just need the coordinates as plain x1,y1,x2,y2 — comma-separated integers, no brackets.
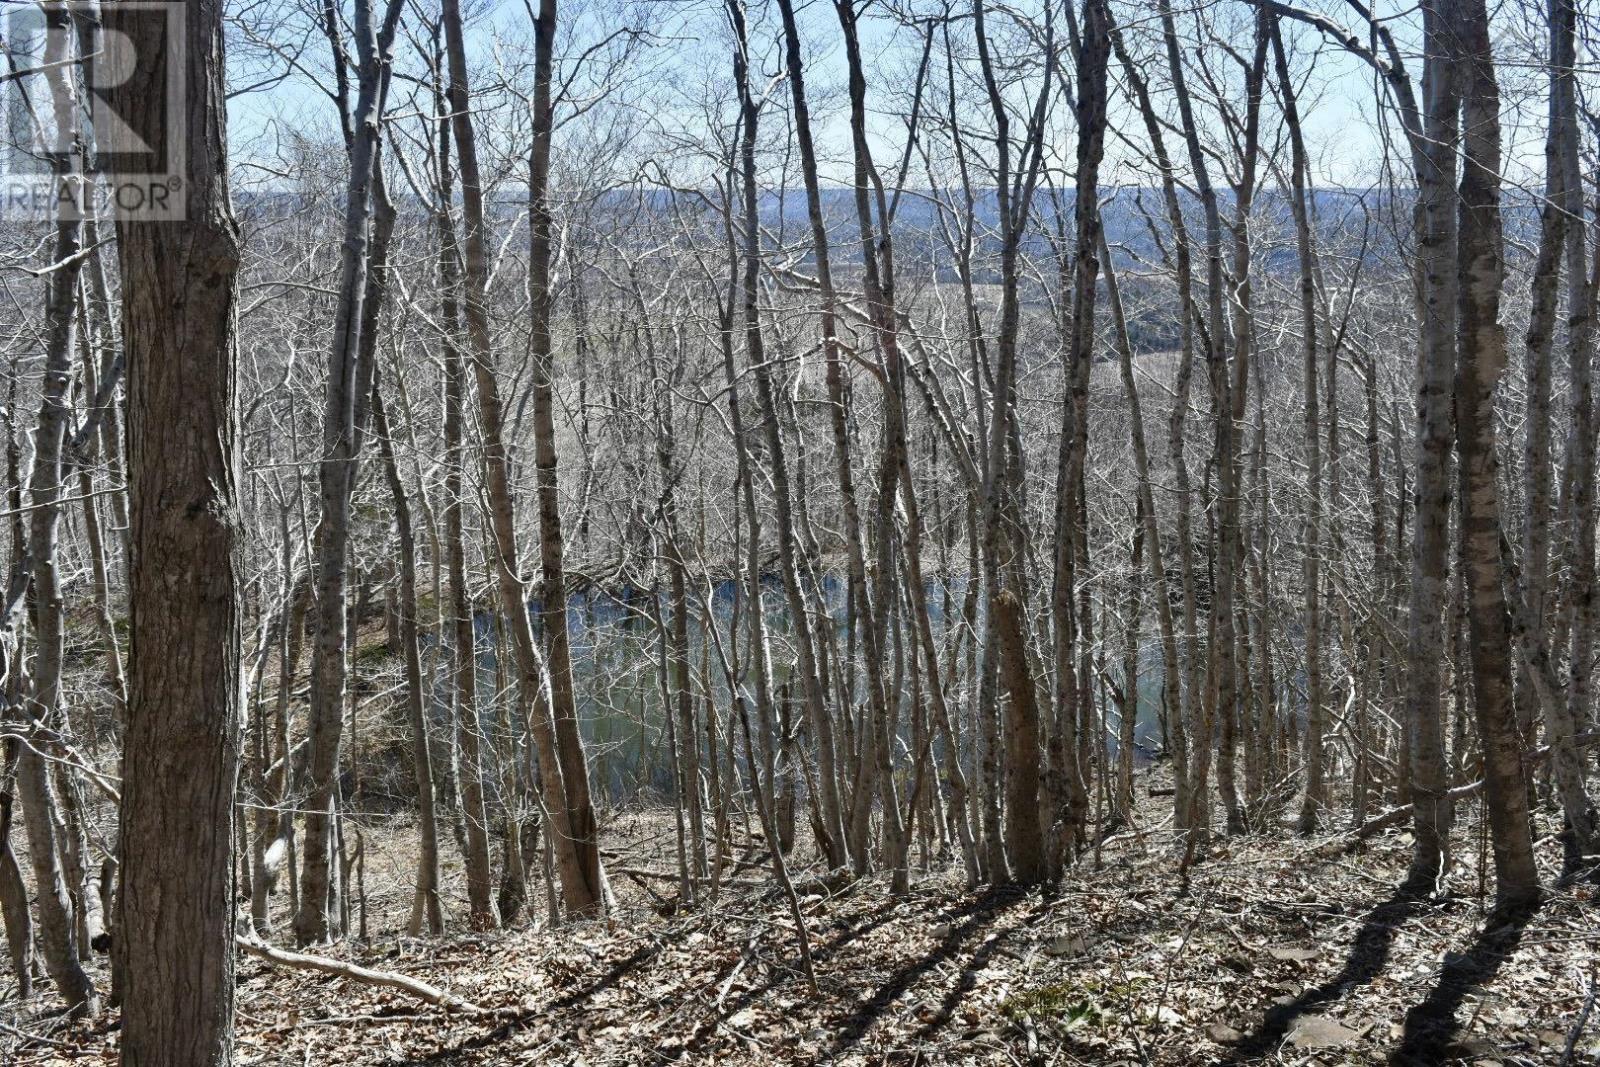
0,777,1600,1067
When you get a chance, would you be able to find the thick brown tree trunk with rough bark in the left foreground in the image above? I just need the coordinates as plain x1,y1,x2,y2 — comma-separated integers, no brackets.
107,0,240,1067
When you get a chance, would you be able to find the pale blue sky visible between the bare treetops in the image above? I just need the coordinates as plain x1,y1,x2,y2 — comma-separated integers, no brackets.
229,0,1544,199
